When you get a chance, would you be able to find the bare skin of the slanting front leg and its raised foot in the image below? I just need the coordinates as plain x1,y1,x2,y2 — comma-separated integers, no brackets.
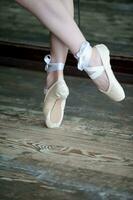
16,0,109,90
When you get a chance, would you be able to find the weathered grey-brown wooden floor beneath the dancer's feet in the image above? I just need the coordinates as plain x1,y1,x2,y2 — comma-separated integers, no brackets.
0,66,133,200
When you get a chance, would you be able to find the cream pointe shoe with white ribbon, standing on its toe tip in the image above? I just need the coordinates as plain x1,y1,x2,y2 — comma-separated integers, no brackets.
43,55,69,128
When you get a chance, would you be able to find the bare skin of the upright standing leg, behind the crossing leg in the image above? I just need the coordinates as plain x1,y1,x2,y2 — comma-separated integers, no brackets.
46,0,74,88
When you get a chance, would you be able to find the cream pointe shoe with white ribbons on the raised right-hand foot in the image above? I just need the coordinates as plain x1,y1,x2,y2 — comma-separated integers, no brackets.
77,42,125,101
